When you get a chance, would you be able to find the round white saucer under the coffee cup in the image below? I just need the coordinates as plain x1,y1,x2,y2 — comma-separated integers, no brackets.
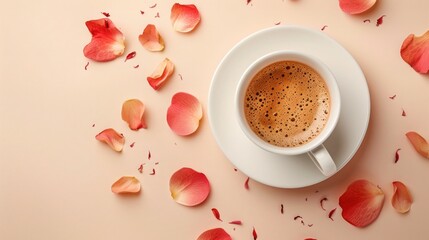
208,26,370,188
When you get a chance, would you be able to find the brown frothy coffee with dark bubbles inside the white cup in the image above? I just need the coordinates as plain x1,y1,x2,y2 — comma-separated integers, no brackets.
244,61,330,147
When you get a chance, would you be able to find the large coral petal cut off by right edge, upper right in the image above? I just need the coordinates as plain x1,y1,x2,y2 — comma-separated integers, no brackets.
401,31,429,73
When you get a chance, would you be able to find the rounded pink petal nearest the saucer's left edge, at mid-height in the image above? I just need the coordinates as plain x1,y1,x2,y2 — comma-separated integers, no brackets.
167,92,203,136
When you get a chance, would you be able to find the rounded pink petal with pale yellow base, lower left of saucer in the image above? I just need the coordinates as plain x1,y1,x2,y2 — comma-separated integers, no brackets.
170,168,210,206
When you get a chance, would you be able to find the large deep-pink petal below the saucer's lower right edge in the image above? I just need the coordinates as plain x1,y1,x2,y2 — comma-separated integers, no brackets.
339,180,384,227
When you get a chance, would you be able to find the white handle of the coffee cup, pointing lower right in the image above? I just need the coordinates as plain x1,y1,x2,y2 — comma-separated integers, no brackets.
308,144,337,177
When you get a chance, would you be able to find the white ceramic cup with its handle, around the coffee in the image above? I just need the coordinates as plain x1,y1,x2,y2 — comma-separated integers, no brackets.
235,50,341,176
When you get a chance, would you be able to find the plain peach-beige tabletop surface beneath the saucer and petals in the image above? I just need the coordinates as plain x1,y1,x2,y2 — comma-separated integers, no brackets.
0,0,429,240
